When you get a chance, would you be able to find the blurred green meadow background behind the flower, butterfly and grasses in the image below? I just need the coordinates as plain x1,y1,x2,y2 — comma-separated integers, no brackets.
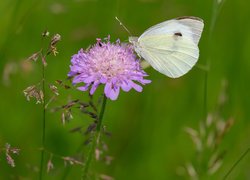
0,0,250,180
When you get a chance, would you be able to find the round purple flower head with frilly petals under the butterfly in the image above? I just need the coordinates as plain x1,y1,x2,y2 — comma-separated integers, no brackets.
68,37,151,100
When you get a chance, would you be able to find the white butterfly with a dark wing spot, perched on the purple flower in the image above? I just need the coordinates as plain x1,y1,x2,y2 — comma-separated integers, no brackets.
129,17,204,78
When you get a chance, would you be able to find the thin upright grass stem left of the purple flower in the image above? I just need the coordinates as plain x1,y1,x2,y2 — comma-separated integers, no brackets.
39,60,46,180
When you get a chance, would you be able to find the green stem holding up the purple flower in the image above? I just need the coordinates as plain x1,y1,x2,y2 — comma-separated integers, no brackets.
82,95,107,180
